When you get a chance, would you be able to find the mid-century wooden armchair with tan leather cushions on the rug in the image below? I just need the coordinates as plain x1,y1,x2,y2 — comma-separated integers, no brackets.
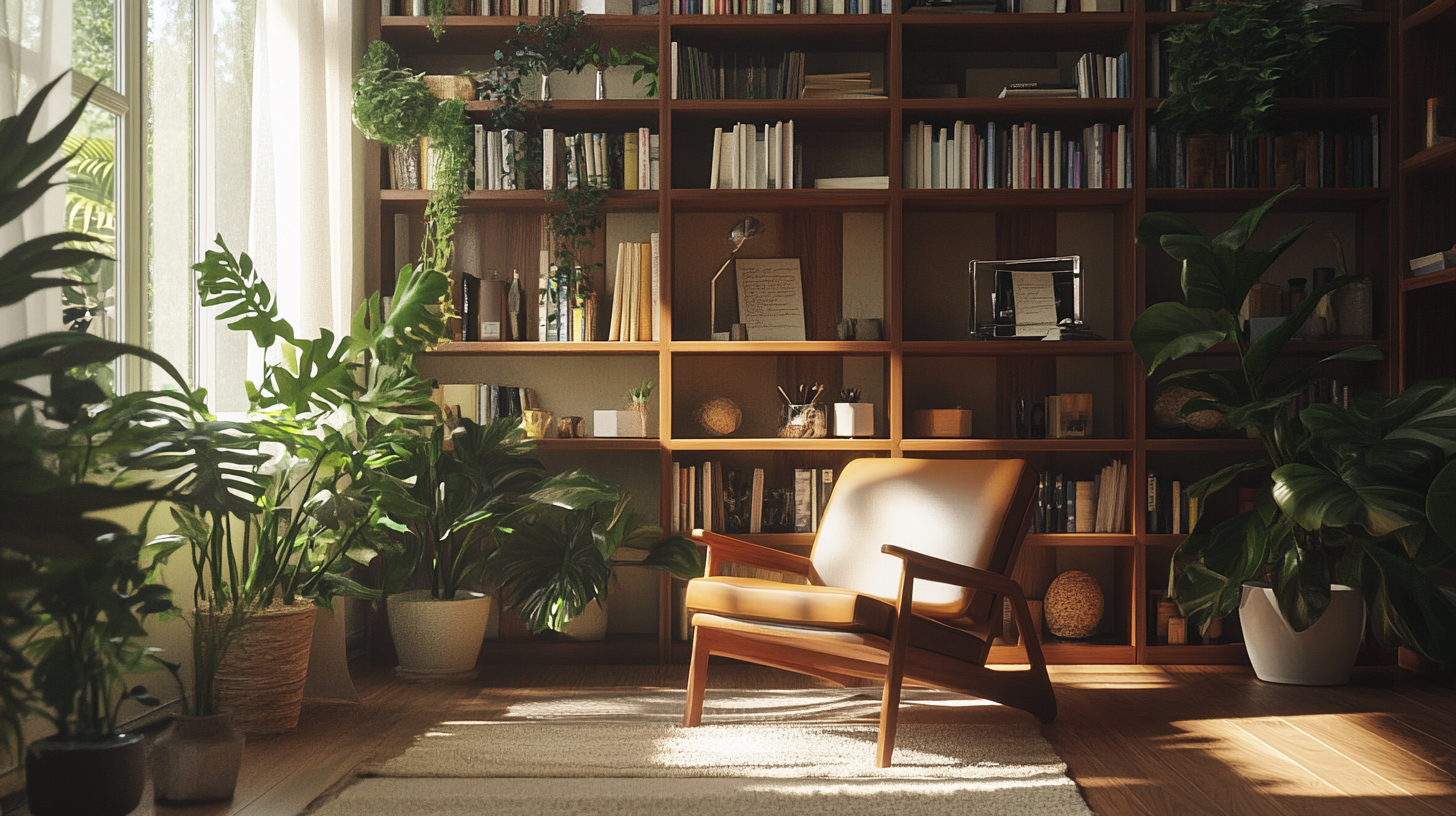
683,459,1057,768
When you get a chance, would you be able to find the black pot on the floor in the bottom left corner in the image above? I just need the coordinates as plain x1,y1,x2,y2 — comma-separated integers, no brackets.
25,734,147,816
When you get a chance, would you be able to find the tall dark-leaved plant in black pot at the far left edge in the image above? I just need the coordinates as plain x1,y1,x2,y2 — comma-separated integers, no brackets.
0,79,185,813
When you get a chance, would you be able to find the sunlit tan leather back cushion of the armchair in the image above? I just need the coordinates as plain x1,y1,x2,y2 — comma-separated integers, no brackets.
811,459,1026,618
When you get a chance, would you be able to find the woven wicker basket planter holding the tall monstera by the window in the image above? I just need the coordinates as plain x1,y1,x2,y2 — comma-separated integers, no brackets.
217,603,319,734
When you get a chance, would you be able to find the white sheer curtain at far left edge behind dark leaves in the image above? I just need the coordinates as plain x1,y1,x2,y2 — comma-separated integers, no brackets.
0,0,74,344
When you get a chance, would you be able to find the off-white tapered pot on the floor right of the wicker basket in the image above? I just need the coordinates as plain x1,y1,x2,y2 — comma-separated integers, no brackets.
387,590,491,679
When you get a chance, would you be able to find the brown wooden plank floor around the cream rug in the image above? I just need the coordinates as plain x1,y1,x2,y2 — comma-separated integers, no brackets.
22,664,1456,816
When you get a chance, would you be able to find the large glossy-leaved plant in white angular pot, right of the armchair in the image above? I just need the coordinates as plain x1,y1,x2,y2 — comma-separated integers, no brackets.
1131,188,1456,683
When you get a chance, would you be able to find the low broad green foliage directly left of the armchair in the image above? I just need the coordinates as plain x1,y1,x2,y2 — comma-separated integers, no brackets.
485,469,703,640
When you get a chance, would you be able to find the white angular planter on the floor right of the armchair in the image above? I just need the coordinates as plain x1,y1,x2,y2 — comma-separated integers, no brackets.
1239,584,1364,686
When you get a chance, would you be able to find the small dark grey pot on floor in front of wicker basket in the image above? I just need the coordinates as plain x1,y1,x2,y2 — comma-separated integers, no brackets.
150,713,246,804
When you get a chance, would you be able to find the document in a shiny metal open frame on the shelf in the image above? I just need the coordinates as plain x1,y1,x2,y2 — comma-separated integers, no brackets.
970,255,1085,340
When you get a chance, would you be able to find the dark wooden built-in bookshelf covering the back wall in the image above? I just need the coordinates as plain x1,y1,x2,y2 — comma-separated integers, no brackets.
365,0,1397,664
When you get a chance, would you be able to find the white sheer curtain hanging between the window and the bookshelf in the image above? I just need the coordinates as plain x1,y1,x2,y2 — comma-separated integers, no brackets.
249,0,364,337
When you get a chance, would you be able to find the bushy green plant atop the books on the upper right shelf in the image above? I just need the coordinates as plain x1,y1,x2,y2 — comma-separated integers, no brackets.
1158,0,1350,136
